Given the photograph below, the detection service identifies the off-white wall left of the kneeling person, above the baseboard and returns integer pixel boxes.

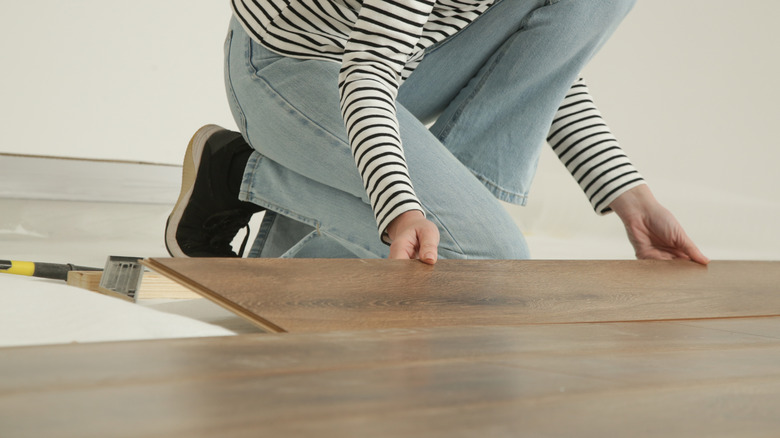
[0,0,233,163]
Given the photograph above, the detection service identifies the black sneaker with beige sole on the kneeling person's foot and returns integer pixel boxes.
[165,125,263,257]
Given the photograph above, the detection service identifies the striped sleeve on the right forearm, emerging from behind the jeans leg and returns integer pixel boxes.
[547,78,645,214]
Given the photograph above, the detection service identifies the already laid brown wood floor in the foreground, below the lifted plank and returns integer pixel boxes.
[0,317,780,438]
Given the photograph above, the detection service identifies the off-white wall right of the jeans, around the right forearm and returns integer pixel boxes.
[518,0,780,259]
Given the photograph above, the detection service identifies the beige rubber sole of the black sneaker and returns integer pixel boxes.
[165,125,225,257]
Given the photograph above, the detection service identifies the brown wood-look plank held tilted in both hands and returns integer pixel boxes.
[140,258,780,332]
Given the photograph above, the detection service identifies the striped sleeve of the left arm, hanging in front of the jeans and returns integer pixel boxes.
[339,0,435,243]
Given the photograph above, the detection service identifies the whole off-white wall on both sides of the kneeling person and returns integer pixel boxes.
[0,0,780,259]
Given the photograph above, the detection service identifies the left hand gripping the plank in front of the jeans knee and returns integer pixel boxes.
[387,210,439,265]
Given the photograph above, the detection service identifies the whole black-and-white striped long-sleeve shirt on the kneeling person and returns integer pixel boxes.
[231,0,641,240]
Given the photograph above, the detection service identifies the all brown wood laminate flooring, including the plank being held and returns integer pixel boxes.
[0,259,780,438]
